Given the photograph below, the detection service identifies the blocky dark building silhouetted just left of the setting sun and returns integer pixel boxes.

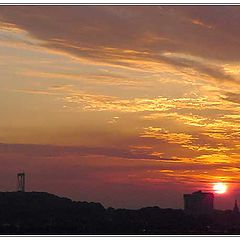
[183,191,214,215]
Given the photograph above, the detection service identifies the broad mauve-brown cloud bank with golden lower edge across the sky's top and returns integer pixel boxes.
[0,6,240,82]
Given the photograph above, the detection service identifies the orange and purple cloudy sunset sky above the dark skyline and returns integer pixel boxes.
[0,6,240,209]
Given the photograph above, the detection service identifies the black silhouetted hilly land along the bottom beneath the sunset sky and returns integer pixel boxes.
[0,192,240,235]
